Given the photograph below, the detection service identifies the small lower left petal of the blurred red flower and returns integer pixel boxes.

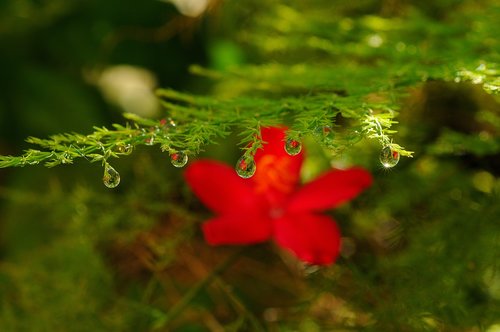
[202,213,272,245]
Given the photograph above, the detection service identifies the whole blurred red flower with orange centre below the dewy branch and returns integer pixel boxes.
[185,127,372,265]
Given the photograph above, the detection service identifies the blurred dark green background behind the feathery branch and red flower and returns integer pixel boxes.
[0,0,500,332]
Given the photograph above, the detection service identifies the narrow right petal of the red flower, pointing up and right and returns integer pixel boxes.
[288,167,372,212]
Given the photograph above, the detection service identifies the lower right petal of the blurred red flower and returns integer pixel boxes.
[274,213,340,265]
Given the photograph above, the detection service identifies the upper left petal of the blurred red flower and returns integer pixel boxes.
[184,160,263,214]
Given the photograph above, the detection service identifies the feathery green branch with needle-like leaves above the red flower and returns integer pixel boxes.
[0,3,500,171]
